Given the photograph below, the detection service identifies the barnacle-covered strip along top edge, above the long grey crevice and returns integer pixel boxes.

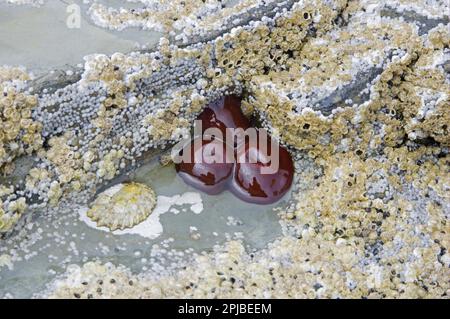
[88,0,292,43]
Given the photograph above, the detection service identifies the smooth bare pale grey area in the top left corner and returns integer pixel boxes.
[0,0,161,72]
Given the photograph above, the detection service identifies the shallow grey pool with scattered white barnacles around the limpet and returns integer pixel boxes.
[0,160,290,298]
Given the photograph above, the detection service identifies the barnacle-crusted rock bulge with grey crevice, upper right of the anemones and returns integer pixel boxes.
[249,18,450,157]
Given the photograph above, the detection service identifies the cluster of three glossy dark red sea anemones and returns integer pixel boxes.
[176,95,294,204]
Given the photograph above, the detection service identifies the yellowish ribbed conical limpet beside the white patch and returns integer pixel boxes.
[87,183,156,231]
